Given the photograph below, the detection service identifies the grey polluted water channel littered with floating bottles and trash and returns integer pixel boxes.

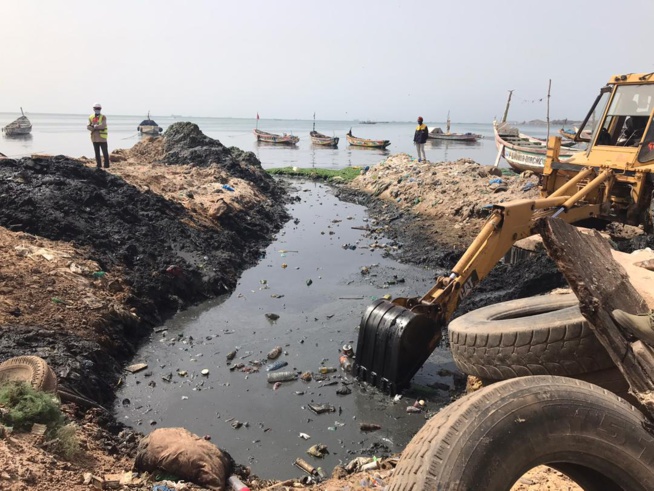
[115,181,455,479]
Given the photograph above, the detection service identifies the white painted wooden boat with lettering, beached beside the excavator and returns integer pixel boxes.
[493,121,581,173]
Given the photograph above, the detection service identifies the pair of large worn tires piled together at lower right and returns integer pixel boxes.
[390,295,654,491]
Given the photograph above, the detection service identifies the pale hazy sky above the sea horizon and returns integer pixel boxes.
[0,0,654,122]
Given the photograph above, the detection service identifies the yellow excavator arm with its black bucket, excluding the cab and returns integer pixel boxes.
[354,168,613,394]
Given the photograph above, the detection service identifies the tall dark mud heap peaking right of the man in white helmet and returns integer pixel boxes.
[163,122,279,194]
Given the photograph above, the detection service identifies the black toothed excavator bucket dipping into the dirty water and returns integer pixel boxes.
[354,300,442,395]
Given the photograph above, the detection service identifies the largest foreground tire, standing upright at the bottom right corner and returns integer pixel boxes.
[390,376,654,491]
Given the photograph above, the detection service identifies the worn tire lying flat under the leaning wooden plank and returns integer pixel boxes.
[448,294,615,380]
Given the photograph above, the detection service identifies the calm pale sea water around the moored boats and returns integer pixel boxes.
[0,113,558,169]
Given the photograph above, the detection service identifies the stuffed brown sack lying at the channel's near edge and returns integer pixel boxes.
[134,428,234,491]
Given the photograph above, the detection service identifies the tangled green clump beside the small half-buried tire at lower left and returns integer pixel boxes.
[0,382,65,431]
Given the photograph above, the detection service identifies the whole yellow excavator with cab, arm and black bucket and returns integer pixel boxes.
[354,73,654,394]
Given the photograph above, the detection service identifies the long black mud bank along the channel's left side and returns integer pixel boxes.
[0,154,288,403]
